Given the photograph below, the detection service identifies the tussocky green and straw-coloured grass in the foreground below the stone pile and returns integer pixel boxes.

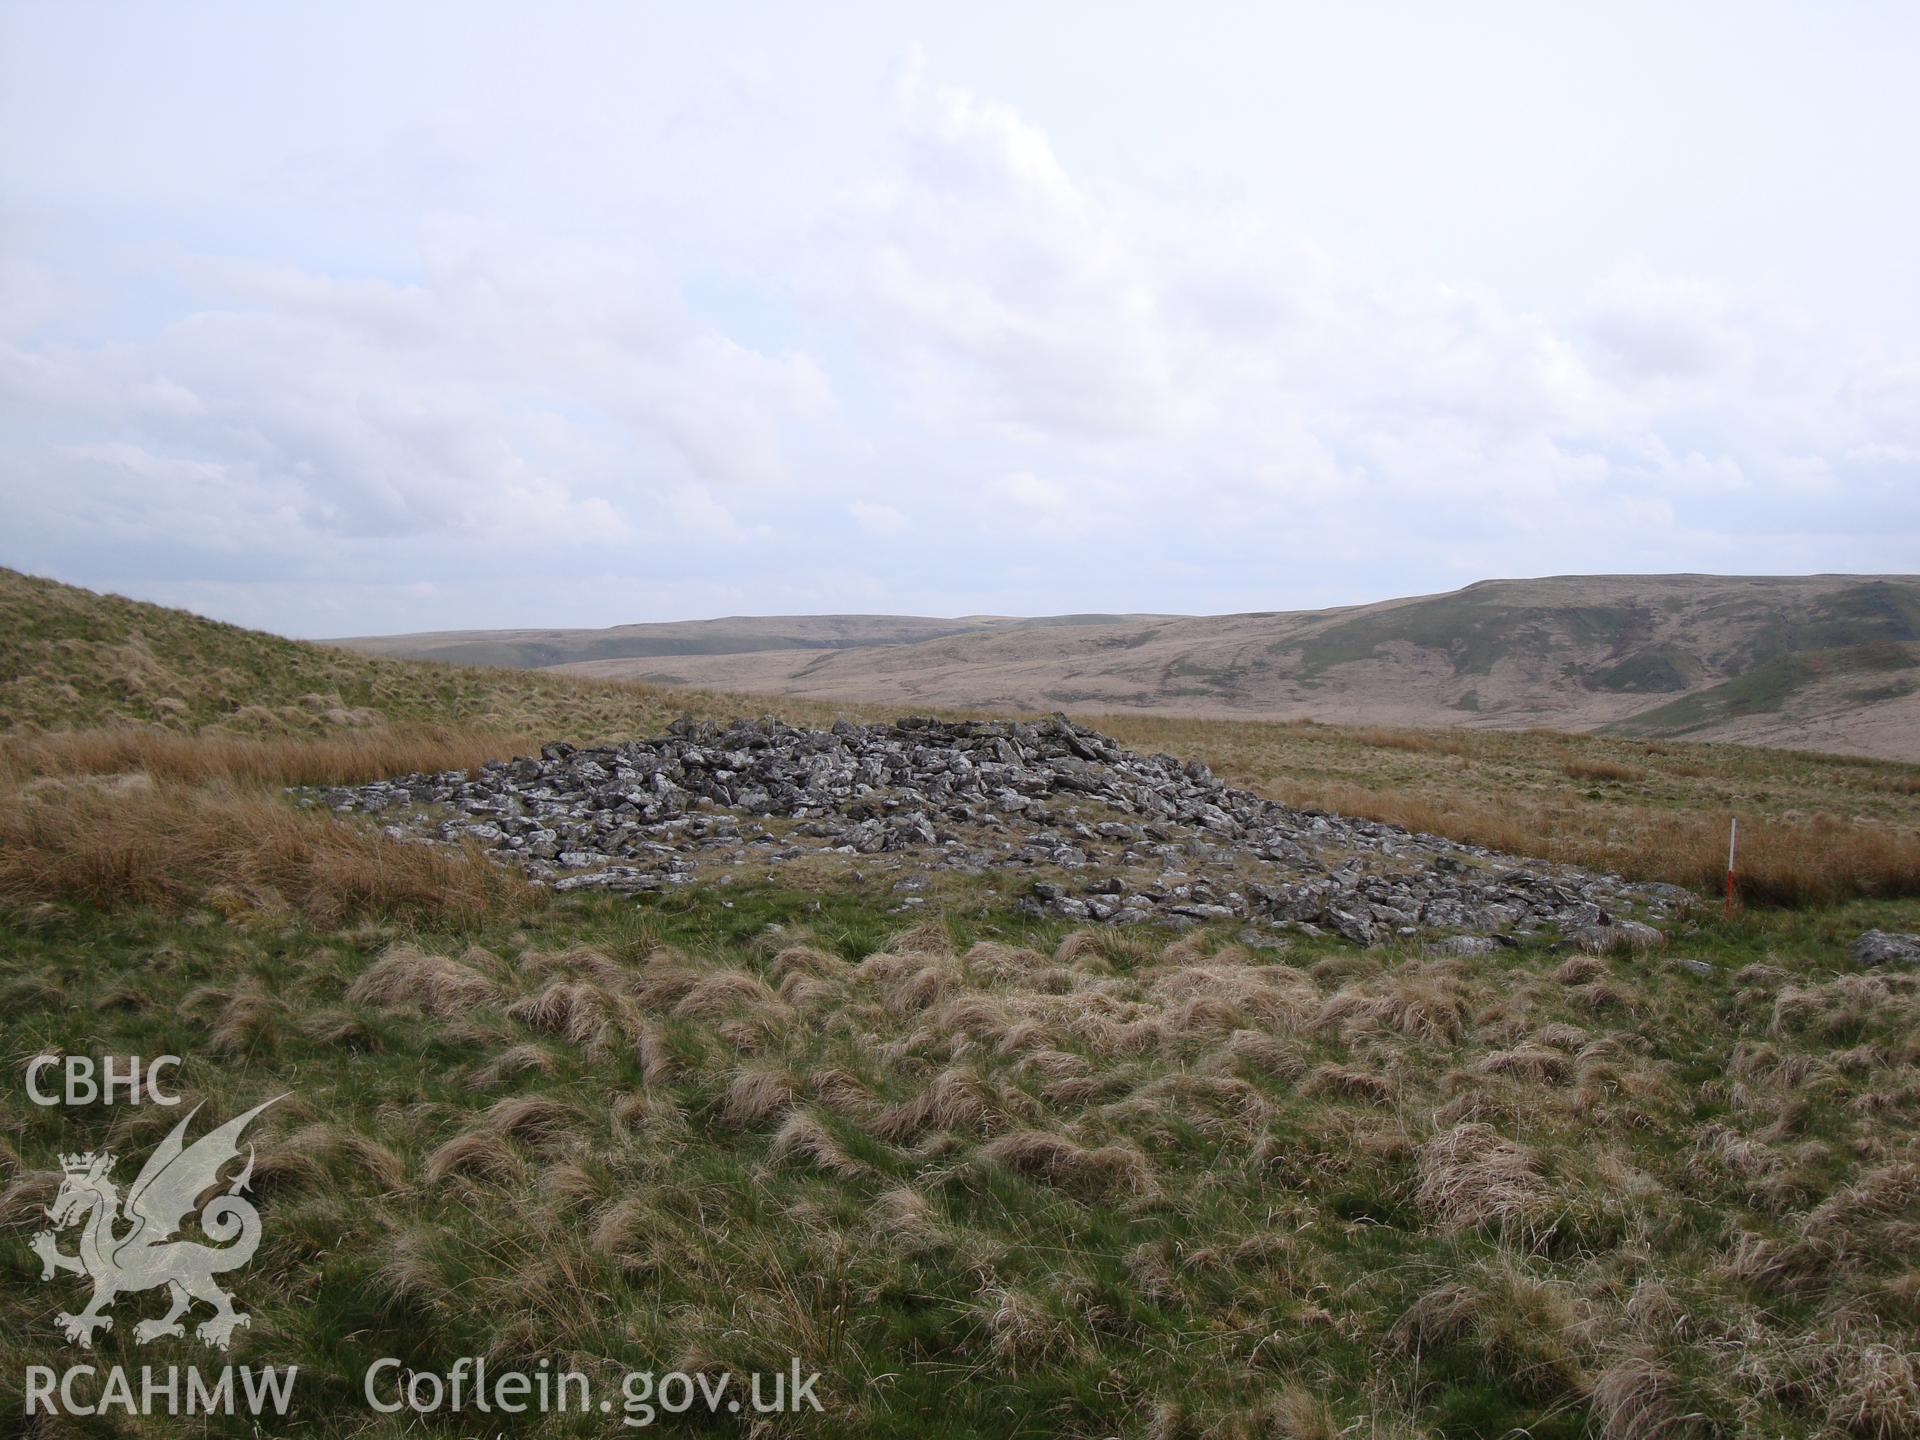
[0,889,1920,1440]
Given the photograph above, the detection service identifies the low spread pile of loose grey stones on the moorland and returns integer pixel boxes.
[307,716,1692,952]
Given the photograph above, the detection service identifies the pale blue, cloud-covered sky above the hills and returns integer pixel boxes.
[0,0,1920,636]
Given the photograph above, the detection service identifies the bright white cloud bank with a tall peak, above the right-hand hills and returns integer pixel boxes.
[841,57,1910,579]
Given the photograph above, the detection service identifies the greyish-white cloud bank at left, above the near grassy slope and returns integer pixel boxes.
[10,227,833,568]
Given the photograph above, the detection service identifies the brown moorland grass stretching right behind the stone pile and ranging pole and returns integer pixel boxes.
[1096,714,1920,904]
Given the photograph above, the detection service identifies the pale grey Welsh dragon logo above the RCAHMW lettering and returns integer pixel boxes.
[31,1094,286,1350]
